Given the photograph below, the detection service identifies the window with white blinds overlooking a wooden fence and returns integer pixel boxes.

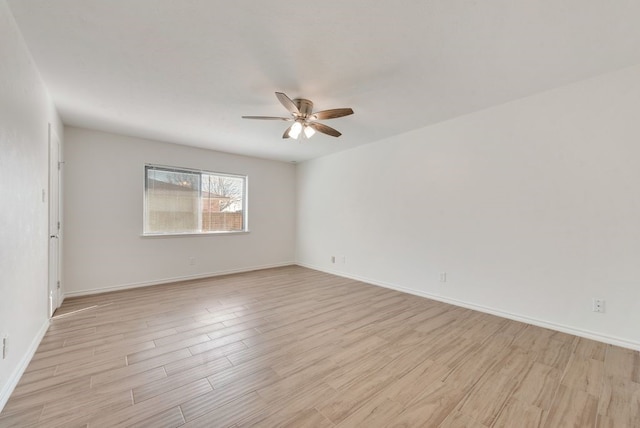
[143,165,247,235]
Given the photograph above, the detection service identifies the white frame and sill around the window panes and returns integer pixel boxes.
[140,163,250,238]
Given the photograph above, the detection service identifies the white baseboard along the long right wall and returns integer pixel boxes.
[297,263,640,351]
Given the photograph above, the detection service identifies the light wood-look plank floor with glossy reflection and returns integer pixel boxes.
[0,266,640,427]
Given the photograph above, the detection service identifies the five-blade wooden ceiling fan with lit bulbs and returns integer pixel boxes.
[242,92,353,139]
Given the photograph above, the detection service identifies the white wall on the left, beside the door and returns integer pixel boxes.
[0,1,63,409]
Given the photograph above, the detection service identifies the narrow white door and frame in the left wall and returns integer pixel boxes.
[47,123,62,318]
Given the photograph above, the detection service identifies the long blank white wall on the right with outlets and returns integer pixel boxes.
[297,66,640,349]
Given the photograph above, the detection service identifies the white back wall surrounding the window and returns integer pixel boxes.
[63,127,295,296]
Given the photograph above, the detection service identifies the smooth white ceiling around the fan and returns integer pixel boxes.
[8,0,640,161]
